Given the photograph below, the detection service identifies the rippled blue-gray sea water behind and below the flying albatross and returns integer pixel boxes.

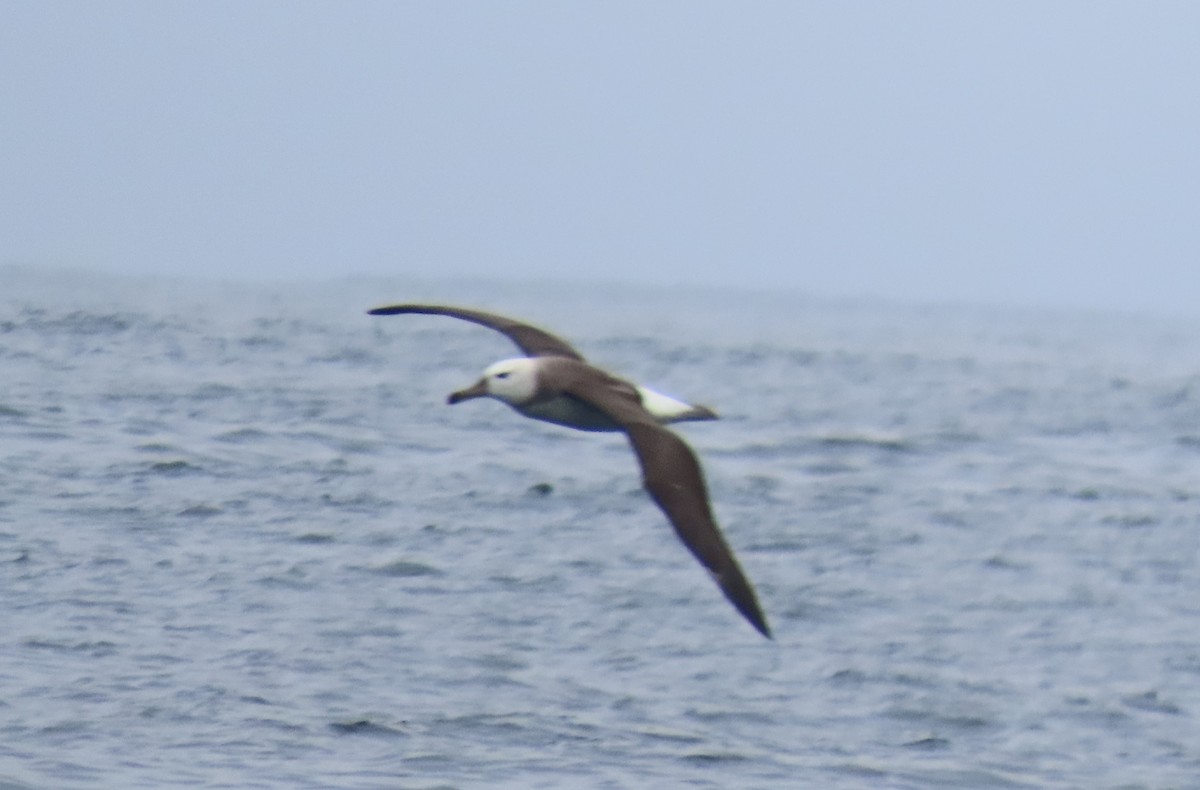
[0,269,1200,790]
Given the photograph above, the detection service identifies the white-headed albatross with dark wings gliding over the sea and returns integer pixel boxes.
[367,298,770,639]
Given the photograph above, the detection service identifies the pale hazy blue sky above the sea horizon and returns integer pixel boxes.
[0,0,1200,315]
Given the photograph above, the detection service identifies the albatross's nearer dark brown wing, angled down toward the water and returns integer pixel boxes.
[552,369,770,639]
